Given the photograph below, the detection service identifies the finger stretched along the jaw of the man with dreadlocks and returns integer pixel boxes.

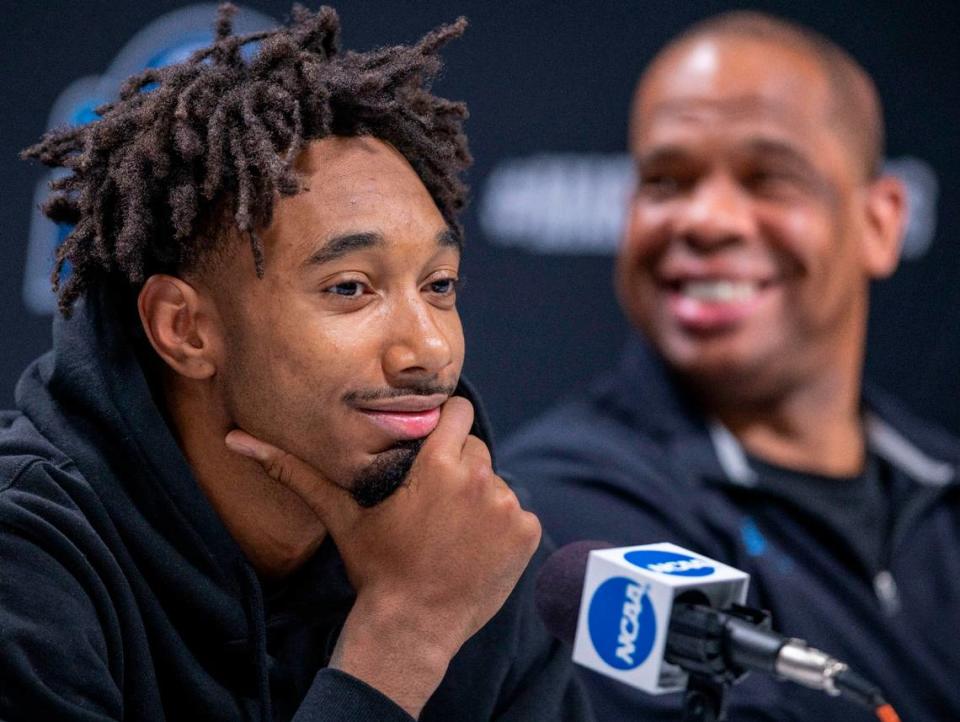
[224,429,355,536]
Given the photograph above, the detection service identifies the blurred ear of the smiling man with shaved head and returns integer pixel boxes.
[863,175,907,279]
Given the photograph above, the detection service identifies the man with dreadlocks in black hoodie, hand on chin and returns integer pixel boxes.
[0,6,586,722]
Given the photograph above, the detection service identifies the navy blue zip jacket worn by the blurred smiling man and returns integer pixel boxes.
[501,339,960,722]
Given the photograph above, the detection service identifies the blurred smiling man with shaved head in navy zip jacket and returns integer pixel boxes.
[505,13,960,722]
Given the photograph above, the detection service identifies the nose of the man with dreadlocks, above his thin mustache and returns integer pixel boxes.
[383,298,453,382]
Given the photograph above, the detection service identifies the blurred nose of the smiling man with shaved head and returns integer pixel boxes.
[674,173,756,251]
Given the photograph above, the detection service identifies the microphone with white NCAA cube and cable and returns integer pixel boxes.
[535,541,898,722]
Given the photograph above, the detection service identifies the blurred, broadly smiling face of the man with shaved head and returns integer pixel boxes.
[617,37,880,394]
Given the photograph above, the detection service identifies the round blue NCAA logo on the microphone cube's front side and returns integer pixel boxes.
[587,577,657,669]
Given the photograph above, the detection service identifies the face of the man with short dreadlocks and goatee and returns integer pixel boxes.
[205,138,464,504]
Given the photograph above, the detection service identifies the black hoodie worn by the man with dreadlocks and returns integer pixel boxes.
[0,294,587,722]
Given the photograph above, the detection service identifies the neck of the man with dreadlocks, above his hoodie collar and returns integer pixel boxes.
[164,379,326,578]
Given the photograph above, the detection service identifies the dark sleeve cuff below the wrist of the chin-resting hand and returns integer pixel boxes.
[291,669,413,722]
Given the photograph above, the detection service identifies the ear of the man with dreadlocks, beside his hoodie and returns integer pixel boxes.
[137,273,219,379]
